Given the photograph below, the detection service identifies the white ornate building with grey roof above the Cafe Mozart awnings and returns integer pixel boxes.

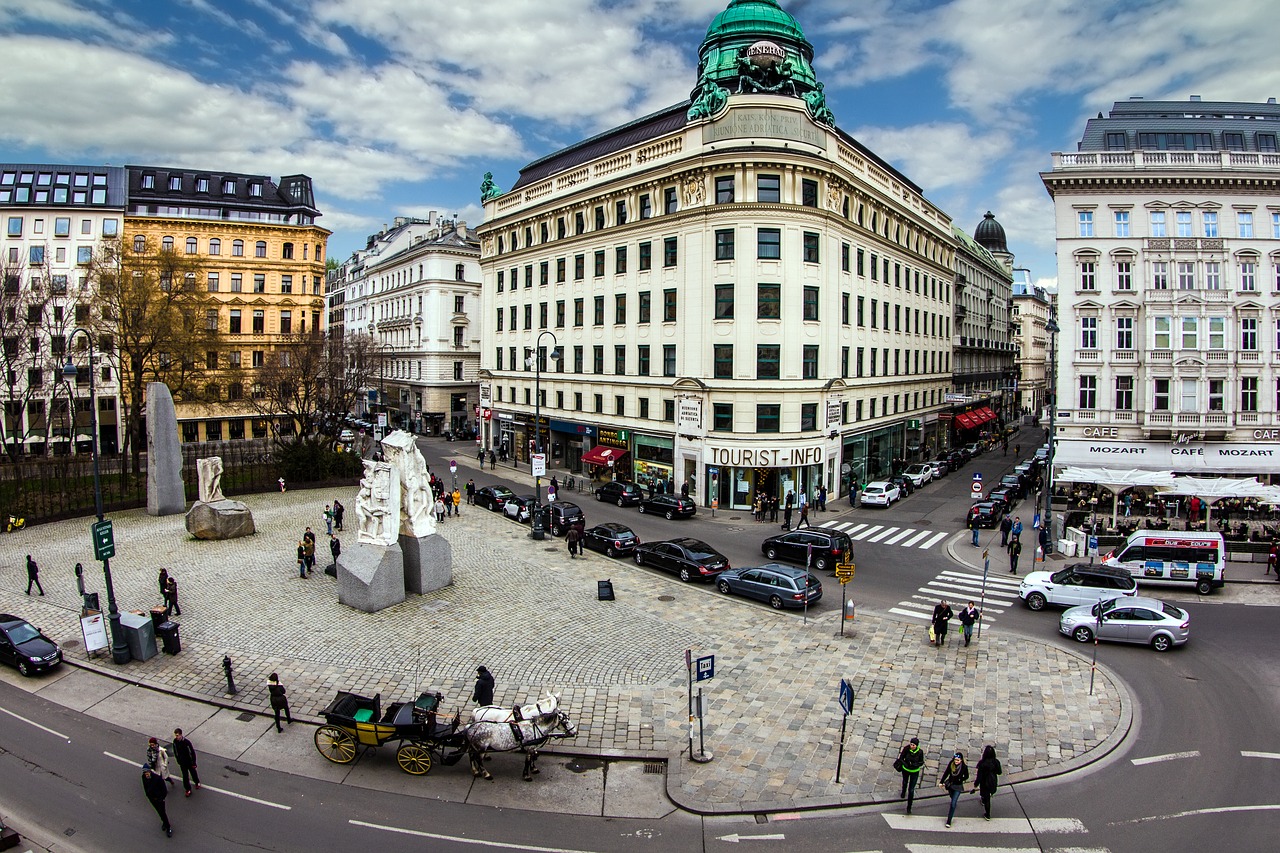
[1041,96,1280,475]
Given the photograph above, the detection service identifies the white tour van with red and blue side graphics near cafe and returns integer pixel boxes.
[1102,530,1226,596]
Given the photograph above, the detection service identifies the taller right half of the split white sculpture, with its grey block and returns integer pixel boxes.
[383,429,453,594]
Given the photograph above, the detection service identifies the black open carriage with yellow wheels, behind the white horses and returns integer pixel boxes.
[315,690,466,776]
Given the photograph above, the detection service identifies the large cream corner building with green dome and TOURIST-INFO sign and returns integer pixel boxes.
[479,0,962,510]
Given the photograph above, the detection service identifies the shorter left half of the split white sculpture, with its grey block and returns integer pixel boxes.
[337,460,404,613]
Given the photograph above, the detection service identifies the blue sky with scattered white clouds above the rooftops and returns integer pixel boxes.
[0,0,1280,283]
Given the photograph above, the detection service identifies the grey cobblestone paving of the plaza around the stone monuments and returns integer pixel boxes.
[0,479,1130,812]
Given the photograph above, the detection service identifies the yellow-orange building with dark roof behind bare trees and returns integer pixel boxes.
[123,165,329,442]
